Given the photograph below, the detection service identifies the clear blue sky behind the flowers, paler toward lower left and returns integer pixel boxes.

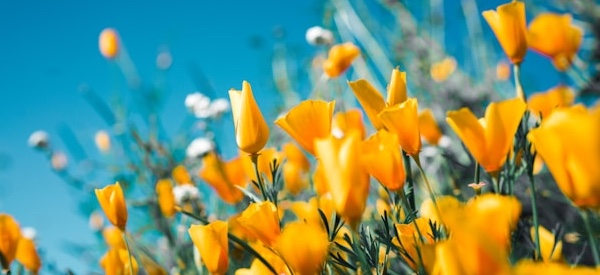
[0,0,572,273]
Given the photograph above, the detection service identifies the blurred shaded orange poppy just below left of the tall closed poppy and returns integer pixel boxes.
[199,152,247,204]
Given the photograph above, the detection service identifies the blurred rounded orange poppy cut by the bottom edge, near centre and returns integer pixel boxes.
[275,221,329,275]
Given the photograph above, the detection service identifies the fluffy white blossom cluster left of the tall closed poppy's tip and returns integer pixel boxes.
[185,92,230,118]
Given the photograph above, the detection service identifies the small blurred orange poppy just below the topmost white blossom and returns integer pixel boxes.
[323,42,360,77]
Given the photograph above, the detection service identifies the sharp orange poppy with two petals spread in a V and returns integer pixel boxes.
[348,69,407,130]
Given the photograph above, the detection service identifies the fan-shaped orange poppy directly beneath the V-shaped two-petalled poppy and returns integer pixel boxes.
[378,98,422,157]
